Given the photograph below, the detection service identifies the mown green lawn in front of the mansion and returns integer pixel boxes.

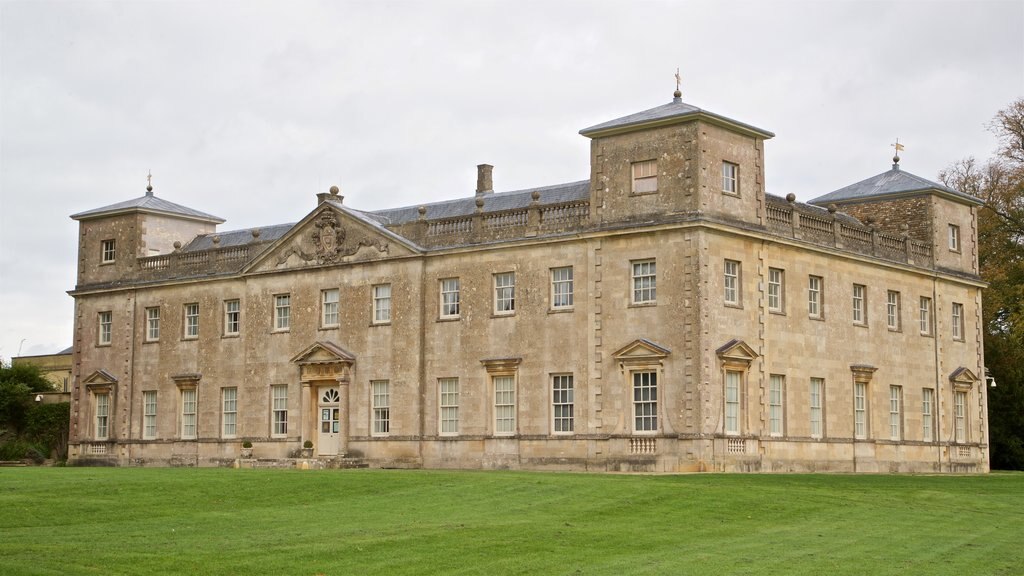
[0,468,1024,576]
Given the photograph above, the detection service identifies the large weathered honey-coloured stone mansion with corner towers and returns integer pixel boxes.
[70,91,989,472]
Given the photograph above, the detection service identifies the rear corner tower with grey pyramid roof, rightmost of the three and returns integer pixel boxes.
[810,156,983,275]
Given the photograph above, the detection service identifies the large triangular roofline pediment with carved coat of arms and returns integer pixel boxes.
[247,202,419,272]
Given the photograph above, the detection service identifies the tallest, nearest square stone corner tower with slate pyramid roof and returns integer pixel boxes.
[580,90,774,224]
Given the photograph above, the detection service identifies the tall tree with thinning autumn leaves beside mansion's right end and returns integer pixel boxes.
[939,98,1024,469]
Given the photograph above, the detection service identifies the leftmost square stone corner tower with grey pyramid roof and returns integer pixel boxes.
[71,186,224,286]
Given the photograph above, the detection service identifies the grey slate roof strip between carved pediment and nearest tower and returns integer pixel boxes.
[364,180,590,224]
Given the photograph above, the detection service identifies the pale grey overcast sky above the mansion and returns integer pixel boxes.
[0,0,1024,360]
